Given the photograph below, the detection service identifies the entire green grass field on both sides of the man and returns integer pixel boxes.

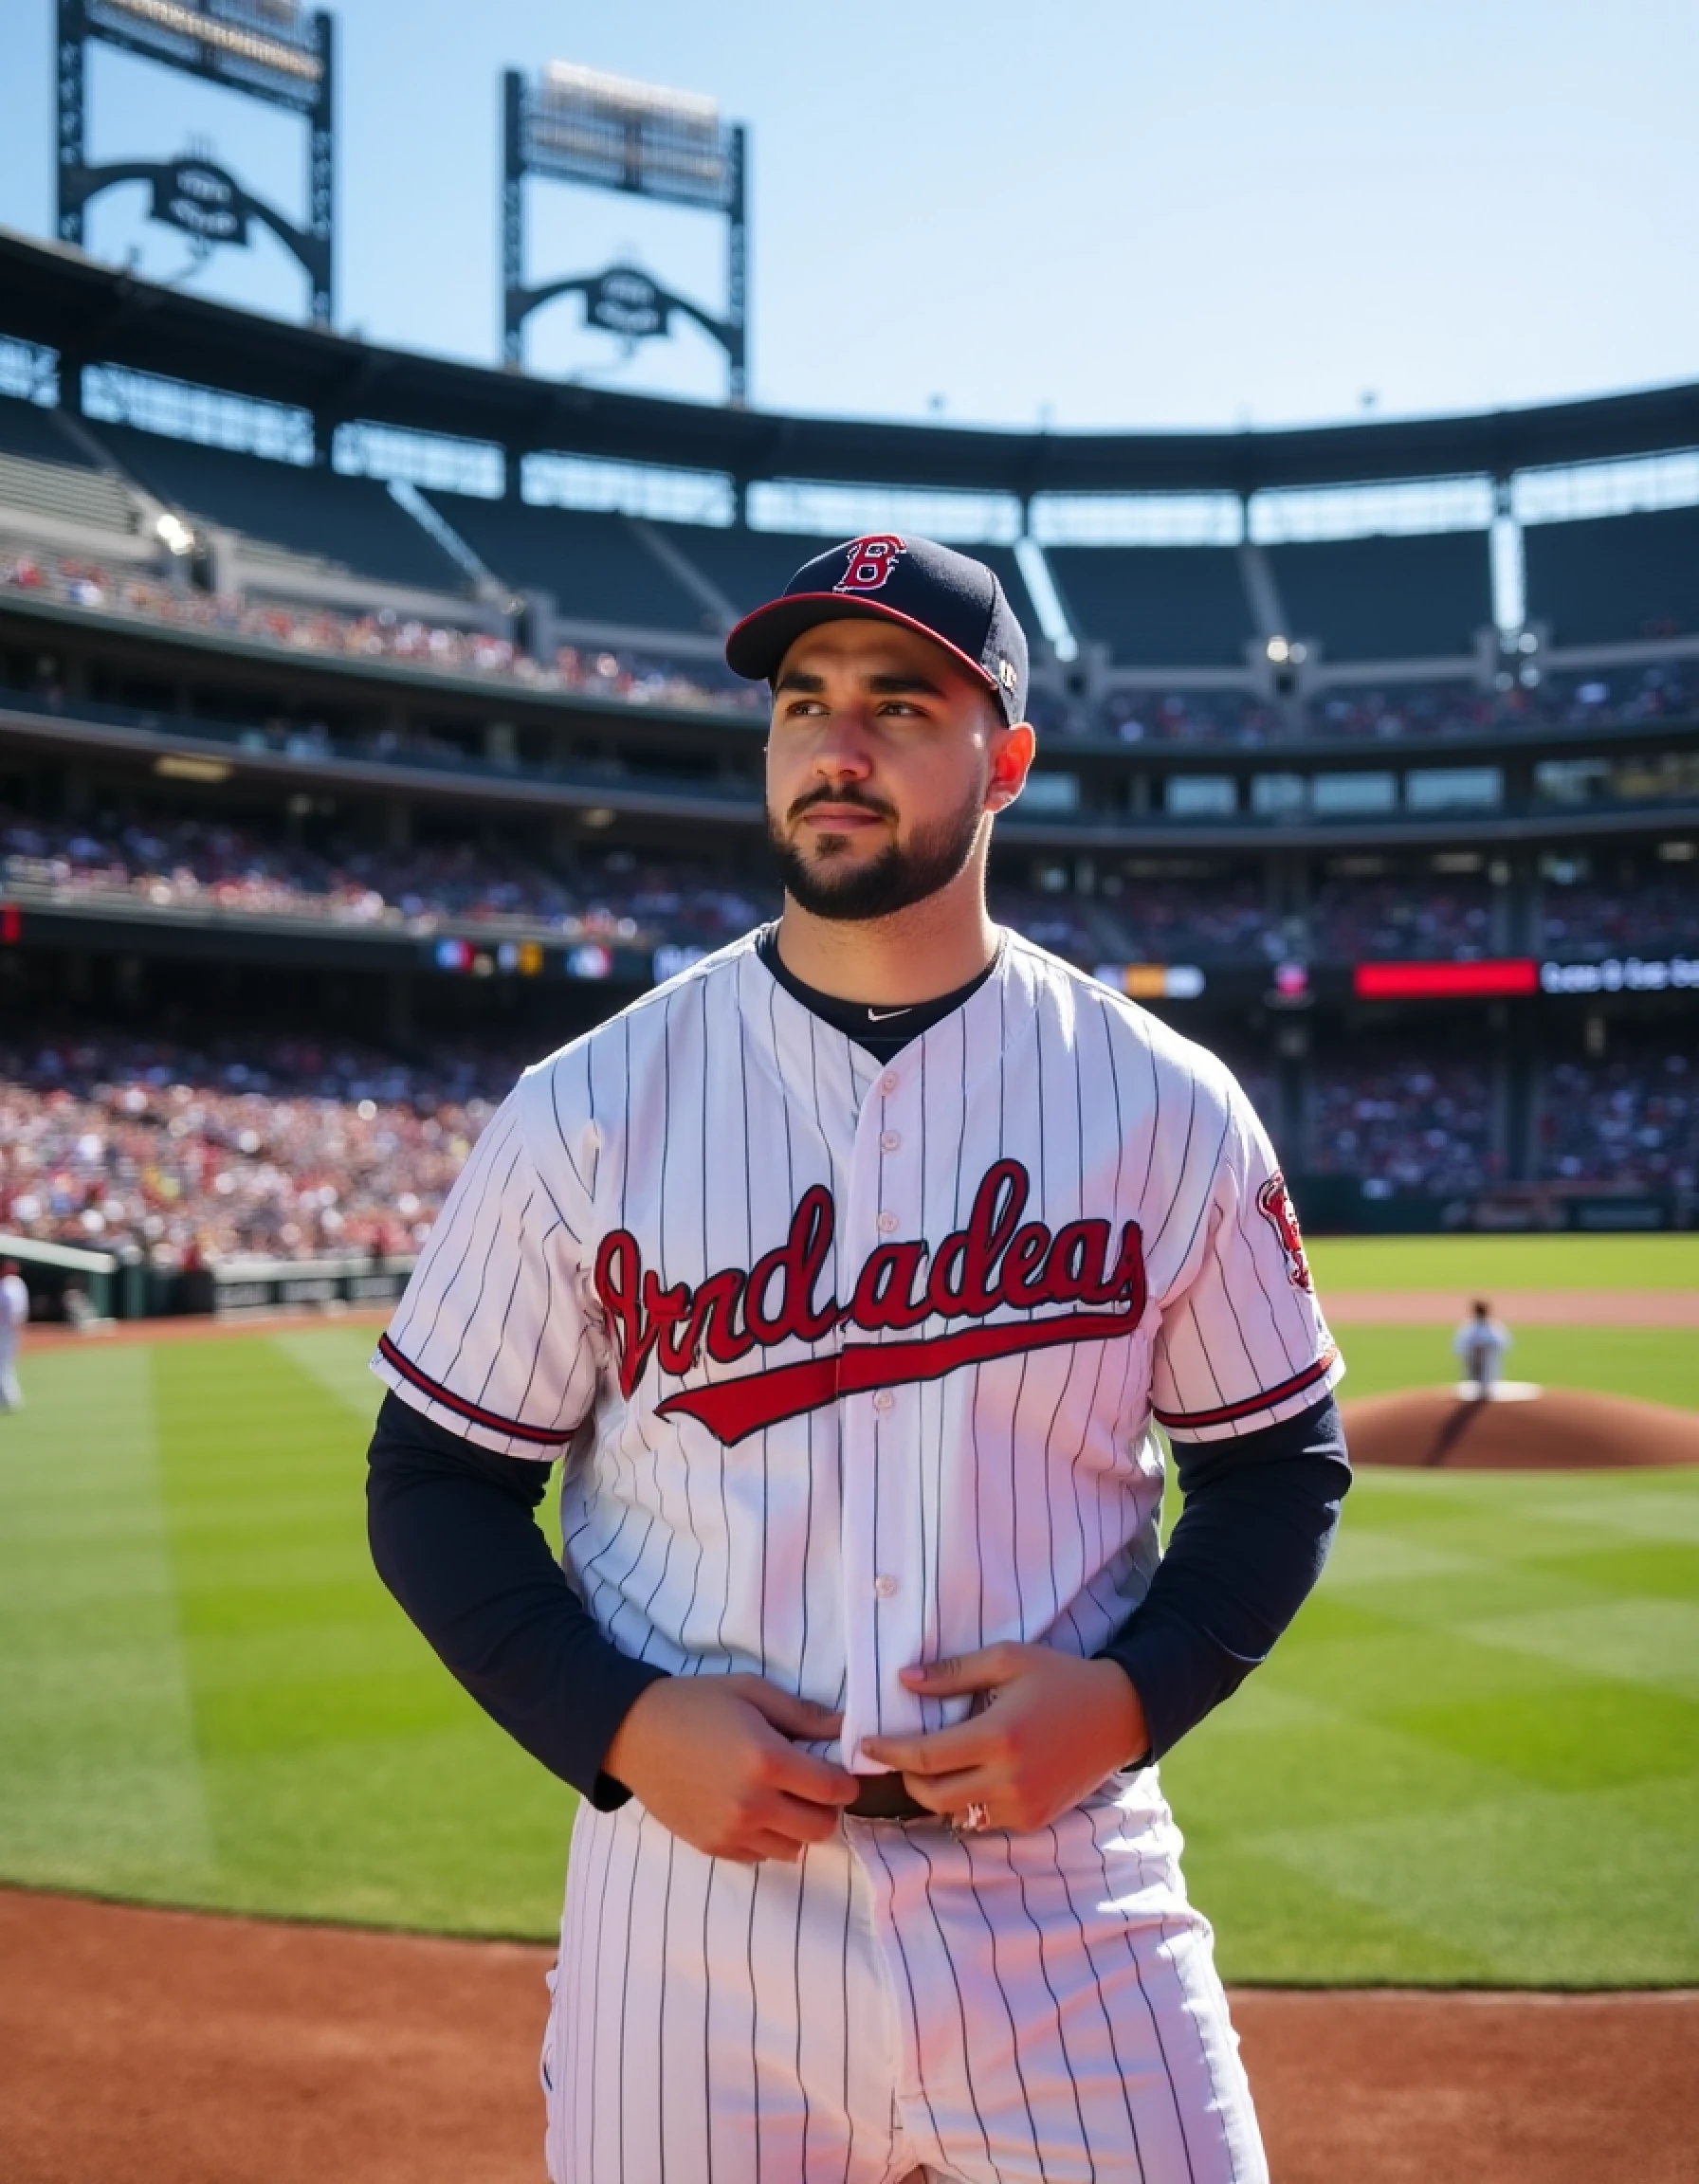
[0,1238,1699,1988]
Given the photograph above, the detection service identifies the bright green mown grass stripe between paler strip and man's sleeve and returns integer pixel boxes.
[153,1328,570,1935]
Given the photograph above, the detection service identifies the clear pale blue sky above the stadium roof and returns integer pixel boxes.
[0,0,1699,426]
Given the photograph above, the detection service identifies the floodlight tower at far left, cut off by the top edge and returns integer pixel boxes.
[57,0,334,325]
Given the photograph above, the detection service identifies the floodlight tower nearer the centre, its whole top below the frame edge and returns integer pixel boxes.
[502,62,749,402]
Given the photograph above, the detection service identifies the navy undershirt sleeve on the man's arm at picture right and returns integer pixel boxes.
[1099,1395,1352,1760]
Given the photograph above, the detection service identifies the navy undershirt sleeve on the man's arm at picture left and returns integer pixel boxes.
[367,1395,667,1812]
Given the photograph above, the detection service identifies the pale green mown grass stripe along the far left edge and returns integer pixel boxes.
[0,1348,210,1894]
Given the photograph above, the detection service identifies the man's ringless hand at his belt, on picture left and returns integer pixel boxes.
[603,1675,858,1866]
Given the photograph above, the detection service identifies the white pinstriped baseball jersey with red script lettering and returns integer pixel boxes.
[374,935,1341,1767]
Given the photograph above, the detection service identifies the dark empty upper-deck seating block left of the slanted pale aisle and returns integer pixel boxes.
[99,424,466,594]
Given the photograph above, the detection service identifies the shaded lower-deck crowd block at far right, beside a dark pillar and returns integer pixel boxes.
[1538,1050,1699,1191]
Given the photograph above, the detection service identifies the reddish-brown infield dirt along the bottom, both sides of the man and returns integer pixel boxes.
[0,1891,1699,2184]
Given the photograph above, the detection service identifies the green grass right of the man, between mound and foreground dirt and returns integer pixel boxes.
[1161,1472,1699,1988]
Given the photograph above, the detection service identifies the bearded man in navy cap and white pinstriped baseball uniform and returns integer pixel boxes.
[372,537,1347,2184]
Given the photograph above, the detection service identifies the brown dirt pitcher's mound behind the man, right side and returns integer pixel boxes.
[1341,1387,1699,1472]
